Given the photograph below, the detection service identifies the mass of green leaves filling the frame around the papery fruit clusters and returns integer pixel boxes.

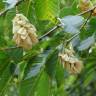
[0,0,96,96]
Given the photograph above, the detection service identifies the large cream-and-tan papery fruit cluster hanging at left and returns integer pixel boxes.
[13,14,38,49]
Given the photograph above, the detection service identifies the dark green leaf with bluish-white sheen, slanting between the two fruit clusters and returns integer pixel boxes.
[25,52,48,80]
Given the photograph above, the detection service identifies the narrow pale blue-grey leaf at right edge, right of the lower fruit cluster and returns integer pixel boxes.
[78,36,95,51]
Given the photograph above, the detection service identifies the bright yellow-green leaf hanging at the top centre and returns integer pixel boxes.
[35,0,59,20]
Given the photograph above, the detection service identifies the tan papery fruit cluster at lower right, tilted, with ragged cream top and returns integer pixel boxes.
[59,49,83,74]
